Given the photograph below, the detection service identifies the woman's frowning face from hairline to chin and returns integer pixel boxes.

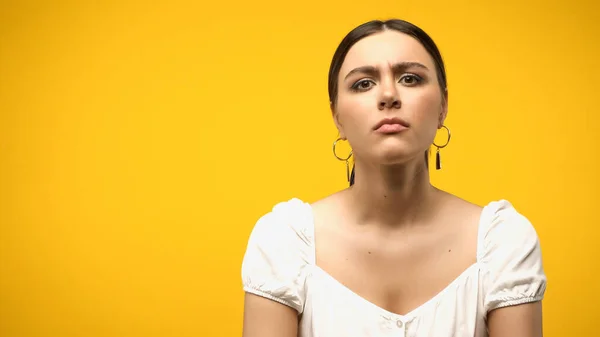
[333,30,447,165]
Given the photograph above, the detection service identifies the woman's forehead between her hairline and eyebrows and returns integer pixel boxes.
[340,30,435,75]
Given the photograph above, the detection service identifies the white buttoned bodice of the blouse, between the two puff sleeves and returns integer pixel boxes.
[299,265,487,337]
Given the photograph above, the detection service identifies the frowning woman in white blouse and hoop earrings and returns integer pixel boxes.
[242,20,546,337]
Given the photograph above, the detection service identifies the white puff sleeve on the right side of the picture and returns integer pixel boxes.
[481,200,547,312]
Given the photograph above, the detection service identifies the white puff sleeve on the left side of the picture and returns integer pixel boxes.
[242,199,313,314]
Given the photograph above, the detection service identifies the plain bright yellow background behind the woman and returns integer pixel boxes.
[0,0,600,337]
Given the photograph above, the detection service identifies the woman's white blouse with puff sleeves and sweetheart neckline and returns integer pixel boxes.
[242,198,546,337]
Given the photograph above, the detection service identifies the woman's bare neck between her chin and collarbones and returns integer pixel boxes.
[348,161,439,227]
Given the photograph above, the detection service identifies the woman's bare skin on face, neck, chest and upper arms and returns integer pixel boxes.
[243,31,542,337]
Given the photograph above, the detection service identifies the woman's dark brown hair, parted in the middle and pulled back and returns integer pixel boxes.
[329,19,447,186]
